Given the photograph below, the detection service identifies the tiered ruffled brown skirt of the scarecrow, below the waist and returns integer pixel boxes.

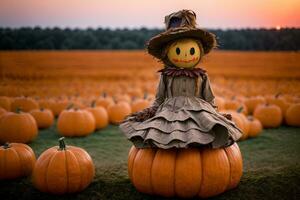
[120,96,242,149]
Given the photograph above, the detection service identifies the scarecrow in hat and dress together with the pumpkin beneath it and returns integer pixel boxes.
[120,10,242,197]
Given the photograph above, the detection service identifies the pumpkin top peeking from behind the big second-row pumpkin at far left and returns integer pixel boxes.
[11,97,39,112]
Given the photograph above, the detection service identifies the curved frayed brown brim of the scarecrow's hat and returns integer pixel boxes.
[147,27,217,59]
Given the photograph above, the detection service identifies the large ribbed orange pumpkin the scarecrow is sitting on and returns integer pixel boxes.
[128,143,243,198]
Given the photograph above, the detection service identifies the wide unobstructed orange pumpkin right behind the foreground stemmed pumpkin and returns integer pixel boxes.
[57,108,96,137]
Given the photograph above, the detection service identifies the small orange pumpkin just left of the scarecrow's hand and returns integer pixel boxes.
[107,101,131,124]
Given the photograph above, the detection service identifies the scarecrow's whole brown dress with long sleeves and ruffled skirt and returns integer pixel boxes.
[120,68,242,149]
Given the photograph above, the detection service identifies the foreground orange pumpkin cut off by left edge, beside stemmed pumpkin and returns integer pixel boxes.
[0,143,35,180]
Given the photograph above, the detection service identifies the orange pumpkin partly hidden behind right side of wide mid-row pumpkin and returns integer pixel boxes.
[86,102,109,129]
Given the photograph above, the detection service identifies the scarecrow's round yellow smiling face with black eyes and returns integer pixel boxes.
[167,39,201,68]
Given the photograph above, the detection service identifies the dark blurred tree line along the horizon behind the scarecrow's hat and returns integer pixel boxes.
[0,27,300,51]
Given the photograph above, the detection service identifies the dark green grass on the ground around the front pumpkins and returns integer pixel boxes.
[0,123,300,200]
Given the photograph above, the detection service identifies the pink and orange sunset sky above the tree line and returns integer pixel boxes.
[0,0,300,29]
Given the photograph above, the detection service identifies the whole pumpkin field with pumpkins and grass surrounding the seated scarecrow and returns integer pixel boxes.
[0,51,300,199]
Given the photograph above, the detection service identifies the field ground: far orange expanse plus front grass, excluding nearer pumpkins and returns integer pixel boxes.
[0,51,300,199]
